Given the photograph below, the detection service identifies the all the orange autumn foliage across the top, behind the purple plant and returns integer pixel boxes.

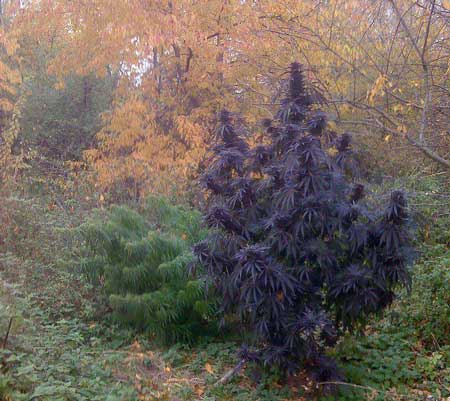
[4,0,449,196]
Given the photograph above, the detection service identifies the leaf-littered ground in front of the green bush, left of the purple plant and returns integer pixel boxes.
[0,254,298,401]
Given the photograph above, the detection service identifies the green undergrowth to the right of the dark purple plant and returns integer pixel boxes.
[326,176,450,401]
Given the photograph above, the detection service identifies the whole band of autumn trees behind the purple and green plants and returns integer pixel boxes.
[0,0,450,202]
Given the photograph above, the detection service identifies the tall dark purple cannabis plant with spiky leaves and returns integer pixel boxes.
[194,63,409,381]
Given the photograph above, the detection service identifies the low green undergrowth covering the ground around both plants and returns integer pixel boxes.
[0,179,450,401]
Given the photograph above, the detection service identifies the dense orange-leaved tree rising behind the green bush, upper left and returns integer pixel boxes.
[13,0,284,196]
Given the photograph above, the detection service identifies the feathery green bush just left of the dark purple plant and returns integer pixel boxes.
[80,198,214,342]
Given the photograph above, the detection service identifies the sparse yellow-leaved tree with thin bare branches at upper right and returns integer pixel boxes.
[253,0,450,168]
